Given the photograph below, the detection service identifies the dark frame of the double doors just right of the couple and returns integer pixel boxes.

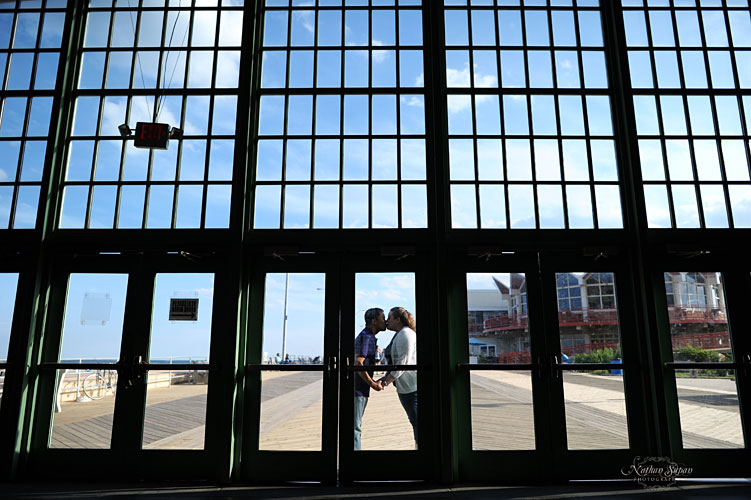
[450,250,651,480]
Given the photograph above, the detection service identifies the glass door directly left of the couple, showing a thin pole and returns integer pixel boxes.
[243,257,340,482]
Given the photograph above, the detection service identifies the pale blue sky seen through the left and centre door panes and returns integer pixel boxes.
[22,273,419,361]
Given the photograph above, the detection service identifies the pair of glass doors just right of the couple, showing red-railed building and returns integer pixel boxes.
[454,255,644,479]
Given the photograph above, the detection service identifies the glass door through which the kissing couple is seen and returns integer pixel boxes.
[339,255,440,481]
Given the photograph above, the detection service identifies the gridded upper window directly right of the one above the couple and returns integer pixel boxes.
[444,0,623,229]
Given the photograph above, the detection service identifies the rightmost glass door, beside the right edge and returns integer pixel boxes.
[655,257,751,477]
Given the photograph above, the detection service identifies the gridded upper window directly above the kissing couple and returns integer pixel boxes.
[253,0,428,229]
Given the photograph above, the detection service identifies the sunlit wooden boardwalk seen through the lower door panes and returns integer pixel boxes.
[50,371,743,451]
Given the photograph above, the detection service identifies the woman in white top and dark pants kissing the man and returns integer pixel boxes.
[380,307,417,449]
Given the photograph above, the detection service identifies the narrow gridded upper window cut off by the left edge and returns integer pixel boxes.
[0,0,66,229]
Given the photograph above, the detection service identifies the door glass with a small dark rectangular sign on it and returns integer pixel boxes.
[142,273,214,449]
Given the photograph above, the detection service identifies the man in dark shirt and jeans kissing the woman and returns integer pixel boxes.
[355,307,386,450]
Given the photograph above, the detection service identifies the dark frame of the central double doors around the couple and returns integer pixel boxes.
[242,248,440,483]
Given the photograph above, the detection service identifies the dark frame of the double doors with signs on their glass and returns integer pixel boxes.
[27,252,239,480]
